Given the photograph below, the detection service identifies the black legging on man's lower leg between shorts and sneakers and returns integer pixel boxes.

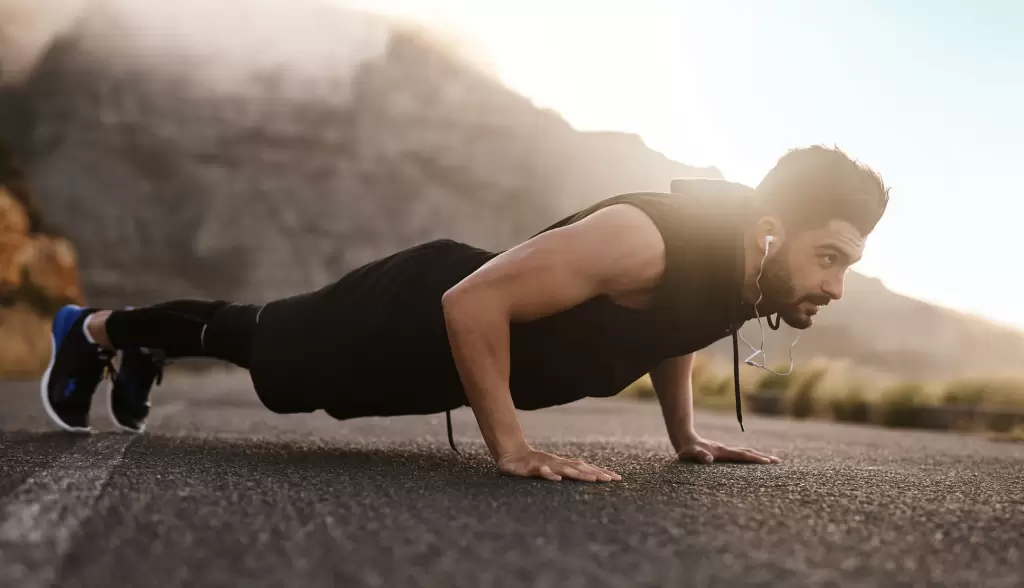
[106,299,260,370]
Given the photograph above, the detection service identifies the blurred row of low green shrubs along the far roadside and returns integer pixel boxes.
[624,354,1024,440]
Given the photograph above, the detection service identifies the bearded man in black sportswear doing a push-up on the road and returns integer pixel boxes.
[41,146,889,481]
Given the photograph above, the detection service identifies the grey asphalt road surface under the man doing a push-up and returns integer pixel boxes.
[0,373,1024,588]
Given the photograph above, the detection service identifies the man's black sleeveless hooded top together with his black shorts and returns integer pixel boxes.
[251,180,753,428]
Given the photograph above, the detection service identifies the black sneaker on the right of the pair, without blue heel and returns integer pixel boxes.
[108,348,165,433]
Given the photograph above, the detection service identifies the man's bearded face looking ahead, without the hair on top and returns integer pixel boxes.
[758,220,864,329]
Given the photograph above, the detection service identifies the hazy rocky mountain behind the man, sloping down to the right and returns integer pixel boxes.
[0,0,1024,385]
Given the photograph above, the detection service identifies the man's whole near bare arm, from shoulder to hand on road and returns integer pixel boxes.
[442,205,665,479]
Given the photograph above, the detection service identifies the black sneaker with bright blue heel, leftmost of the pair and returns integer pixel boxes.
[39,304,114,432]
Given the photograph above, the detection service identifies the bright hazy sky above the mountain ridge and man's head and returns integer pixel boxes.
[349,0,1024,328]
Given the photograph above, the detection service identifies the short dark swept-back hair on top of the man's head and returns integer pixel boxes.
[757,145,889,236]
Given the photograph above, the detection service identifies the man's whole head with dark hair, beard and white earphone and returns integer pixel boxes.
[746,145,889,329]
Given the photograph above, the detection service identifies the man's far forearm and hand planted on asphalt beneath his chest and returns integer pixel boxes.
[650,353,779,463]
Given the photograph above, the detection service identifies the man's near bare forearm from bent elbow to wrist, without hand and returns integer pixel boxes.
[444,296,526,461]
